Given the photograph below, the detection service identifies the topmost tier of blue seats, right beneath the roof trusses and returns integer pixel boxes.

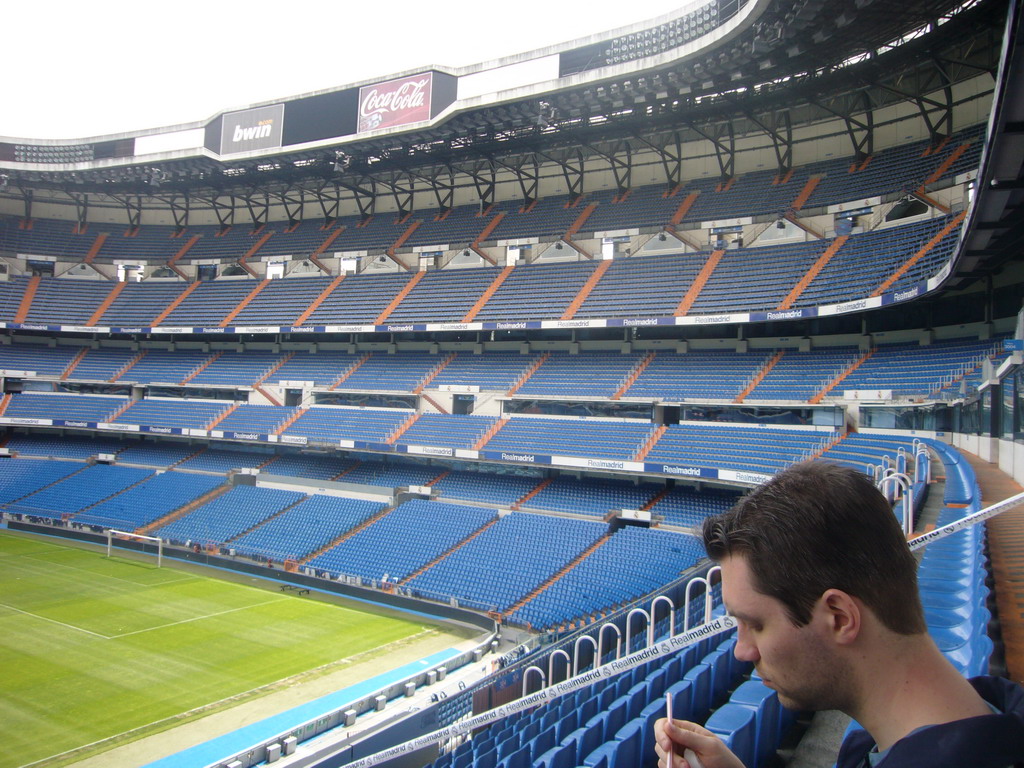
[0,124,985,280]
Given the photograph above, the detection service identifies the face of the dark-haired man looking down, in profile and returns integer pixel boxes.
[721,555,852,711]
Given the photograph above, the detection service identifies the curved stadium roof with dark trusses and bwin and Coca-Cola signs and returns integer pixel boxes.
[0,0,1007,208]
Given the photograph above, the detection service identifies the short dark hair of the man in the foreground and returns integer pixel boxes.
[703,462,926,635]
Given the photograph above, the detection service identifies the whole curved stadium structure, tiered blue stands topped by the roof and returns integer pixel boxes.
[0,0,1024,765]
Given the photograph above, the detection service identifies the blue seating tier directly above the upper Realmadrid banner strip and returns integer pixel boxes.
[0,216,959,328]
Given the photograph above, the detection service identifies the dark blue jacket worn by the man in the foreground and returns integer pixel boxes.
[836,677,1024,768]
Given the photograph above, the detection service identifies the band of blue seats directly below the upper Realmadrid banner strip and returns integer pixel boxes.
[0,336,1008,399]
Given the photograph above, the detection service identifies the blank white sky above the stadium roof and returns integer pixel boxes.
[0,0,686,139]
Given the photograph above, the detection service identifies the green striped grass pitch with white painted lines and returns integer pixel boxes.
[0,530,436,768]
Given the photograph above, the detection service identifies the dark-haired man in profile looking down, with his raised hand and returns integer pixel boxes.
[654,462,1024,768]
